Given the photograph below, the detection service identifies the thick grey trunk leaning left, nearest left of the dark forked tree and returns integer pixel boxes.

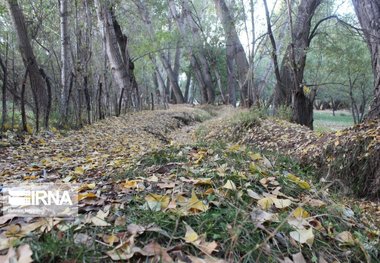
[214,0,252,107]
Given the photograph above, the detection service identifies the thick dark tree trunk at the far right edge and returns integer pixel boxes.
[352,0,380,119]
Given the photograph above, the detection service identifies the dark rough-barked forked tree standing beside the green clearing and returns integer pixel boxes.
[274,0,322,129]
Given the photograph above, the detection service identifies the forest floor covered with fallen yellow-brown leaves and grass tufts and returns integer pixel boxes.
[0,106,380,263]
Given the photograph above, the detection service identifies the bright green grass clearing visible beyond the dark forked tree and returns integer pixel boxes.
[314,110,354,132]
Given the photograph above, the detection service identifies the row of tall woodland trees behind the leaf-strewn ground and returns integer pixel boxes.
[0,0,380,130]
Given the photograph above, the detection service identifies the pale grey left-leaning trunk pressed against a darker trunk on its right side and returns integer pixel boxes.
[95,0,132,113]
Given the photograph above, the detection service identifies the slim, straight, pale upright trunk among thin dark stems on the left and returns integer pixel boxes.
[59,0,70,124]
